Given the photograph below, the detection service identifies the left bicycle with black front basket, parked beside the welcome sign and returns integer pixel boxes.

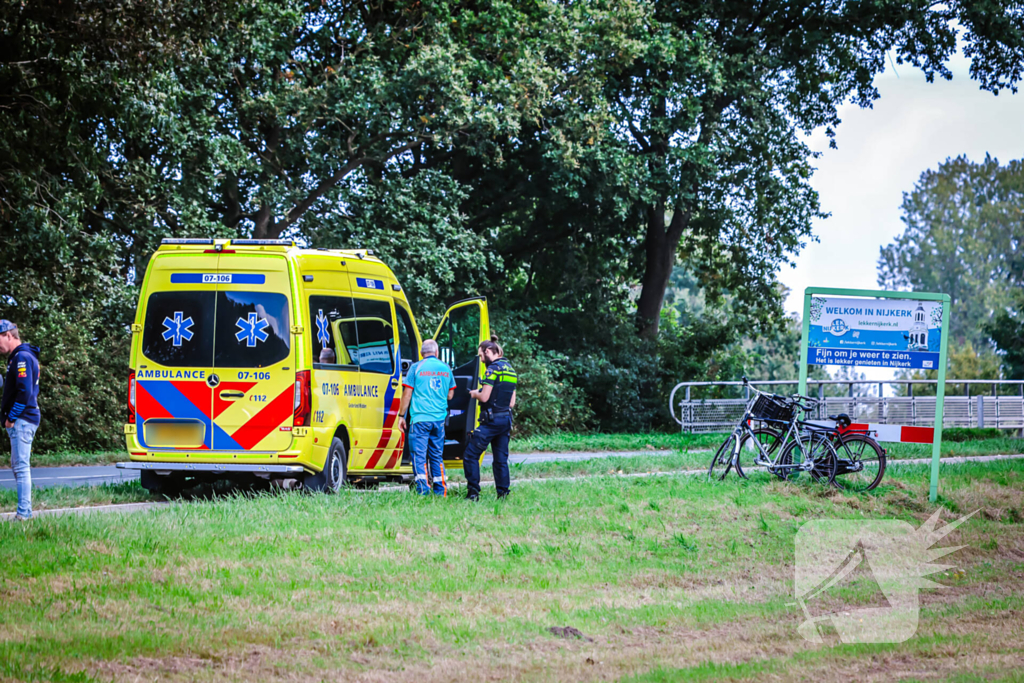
[708,377,839,485]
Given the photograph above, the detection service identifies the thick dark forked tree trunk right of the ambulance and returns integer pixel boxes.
[637,200,689,339]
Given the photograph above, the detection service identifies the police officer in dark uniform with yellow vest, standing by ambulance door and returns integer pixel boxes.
[462,338,517,501]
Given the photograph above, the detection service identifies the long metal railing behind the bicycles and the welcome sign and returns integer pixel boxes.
[669,380,1024,435]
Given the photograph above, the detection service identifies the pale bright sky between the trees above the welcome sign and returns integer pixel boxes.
[779,56,1024,394]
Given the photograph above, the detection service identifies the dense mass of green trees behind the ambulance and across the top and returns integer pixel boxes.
[0,0,1024,442]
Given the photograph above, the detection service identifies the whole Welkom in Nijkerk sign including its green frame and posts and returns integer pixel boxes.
[800,287,950,502]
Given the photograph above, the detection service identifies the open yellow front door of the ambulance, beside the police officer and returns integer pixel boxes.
[434,297,490,467]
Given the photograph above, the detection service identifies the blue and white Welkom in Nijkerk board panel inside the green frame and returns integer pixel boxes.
[807,297,942,370]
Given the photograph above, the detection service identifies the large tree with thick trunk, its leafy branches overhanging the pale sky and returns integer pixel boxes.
[607,0,1024,336]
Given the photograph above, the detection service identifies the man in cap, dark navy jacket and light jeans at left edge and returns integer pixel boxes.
[0,319,39,520]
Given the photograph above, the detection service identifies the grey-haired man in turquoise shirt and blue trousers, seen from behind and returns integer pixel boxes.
[398,339,455,496]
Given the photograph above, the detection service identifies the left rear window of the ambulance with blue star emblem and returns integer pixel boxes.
[142,292,214,368]
